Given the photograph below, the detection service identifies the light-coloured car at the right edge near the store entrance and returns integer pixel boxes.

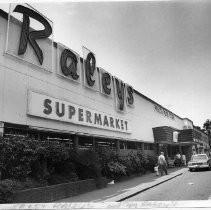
[188,154,211,171]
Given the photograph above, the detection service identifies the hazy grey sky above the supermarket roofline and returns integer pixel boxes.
[0,0,211,127]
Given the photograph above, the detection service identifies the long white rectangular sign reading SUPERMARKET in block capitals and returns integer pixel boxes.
[28,91,131,133]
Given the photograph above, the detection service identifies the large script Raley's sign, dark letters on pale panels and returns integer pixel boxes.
[6,4,134,112]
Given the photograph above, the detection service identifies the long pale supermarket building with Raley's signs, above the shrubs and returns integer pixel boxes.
[0,4,209,162]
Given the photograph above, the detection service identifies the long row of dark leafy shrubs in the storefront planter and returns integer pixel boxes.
[0,136,157,203]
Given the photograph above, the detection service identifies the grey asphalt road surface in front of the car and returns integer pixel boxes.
[125,170,211,201]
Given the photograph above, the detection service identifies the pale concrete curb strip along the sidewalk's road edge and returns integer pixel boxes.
[102,168,188,202]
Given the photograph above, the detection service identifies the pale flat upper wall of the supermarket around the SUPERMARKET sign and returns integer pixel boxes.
[0,10,188,142]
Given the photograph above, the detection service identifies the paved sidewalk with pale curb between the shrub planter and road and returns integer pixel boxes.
[56,168,188,203]
